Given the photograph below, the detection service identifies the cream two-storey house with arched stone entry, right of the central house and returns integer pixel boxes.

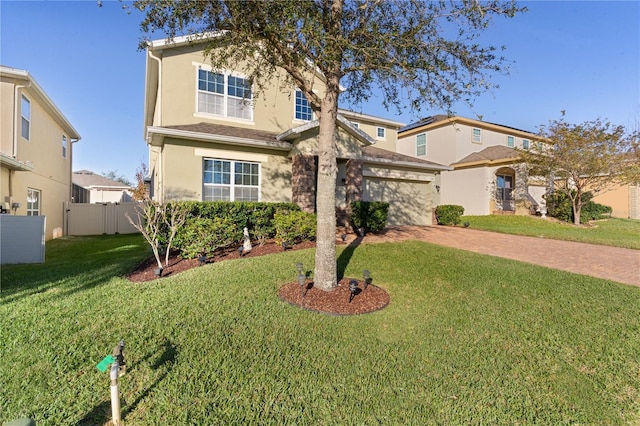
[397,115,546,215]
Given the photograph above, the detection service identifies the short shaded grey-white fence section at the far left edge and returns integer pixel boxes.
[0,214,46,264]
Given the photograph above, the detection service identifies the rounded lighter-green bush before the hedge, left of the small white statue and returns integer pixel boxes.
[174,217,242,259]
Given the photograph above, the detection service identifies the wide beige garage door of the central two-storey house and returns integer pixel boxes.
[363,177,432,226]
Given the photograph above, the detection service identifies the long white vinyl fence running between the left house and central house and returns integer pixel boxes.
[64,202,138,235]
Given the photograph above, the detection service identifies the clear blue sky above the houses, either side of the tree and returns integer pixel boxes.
[0,0,640,181]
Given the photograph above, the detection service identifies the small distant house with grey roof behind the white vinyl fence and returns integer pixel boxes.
[72,170,133,203]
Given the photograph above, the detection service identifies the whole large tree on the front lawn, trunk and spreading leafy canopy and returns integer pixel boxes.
[133,0,523,290]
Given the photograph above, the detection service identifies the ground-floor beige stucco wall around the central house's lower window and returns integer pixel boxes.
[154,138,291,202]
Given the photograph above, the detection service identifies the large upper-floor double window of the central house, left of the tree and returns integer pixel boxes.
[198,69,253,120]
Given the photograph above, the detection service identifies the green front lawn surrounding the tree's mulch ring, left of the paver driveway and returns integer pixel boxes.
[0,235,640,426]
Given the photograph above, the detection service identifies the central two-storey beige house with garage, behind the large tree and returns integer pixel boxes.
[145,37,450,225]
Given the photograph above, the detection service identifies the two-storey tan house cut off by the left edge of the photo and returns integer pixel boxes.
[0,66,80,240]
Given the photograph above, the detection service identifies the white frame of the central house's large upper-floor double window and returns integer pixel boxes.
[195,66,254,122]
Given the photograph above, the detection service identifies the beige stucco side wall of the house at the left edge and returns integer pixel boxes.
[0,81,72,240]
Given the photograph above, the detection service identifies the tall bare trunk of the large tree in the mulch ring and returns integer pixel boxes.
[313,82,339,291]
